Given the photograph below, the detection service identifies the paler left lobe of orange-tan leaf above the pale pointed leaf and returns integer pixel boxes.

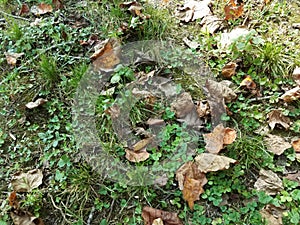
[203,124,224,154]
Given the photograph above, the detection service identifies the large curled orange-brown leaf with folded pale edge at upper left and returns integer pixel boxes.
[90,38,120,71]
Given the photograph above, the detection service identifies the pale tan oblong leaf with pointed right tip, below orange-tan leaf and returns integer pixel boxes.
[195,153,236,173]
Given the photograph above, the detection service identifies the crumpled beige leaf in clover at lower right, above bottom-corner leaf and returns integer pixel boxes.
[254,169,283,195]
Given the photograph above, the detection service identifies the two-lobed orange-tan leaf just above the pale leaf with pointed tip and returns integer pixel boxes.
[203,124,236,154]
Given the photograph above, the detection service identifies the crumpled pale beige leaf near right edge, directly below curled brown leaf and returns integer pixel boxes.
[264,134,292,155]
